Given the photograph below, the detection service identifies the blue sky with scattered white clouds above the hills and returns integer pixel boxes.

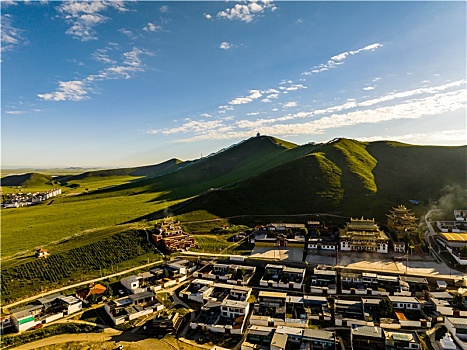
[1,1,467,167]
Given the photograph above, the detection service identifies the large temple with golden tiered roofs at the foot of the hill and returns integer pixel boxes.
[339,217,389,253]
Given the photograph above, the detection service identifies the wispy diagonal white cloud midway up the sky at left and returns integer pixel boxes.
[37,47,151,101]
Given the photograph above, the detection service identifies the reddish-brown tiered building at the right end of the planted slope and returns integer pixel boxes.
[152,218,196,253]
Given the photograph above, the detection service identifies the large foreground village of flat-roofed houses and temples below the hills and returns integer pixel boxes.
[2,205,467,350]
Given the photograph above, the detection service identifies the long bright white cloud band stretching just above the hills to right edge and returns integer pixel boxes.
[152,84,467,142]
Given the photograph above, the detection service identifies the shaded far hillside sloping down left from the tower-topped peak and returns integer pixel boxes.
[92,136,317,200]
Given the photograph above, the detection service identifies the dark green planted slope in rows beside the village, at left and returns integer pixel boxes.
[1,230,160,303]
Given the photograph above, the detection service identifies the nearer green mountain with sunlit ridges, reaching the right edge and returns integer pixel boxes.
[153,139,467,218]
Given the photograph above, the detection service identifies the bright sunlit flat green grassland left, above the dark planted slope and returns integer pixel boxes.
[1,193,186,258]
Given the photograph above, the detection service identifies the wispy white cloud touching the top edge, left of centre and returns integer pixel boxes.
[56,0,128,41]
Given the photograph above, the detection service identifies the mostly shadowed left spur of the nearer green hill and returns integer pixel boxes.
[170,153,343,217]
